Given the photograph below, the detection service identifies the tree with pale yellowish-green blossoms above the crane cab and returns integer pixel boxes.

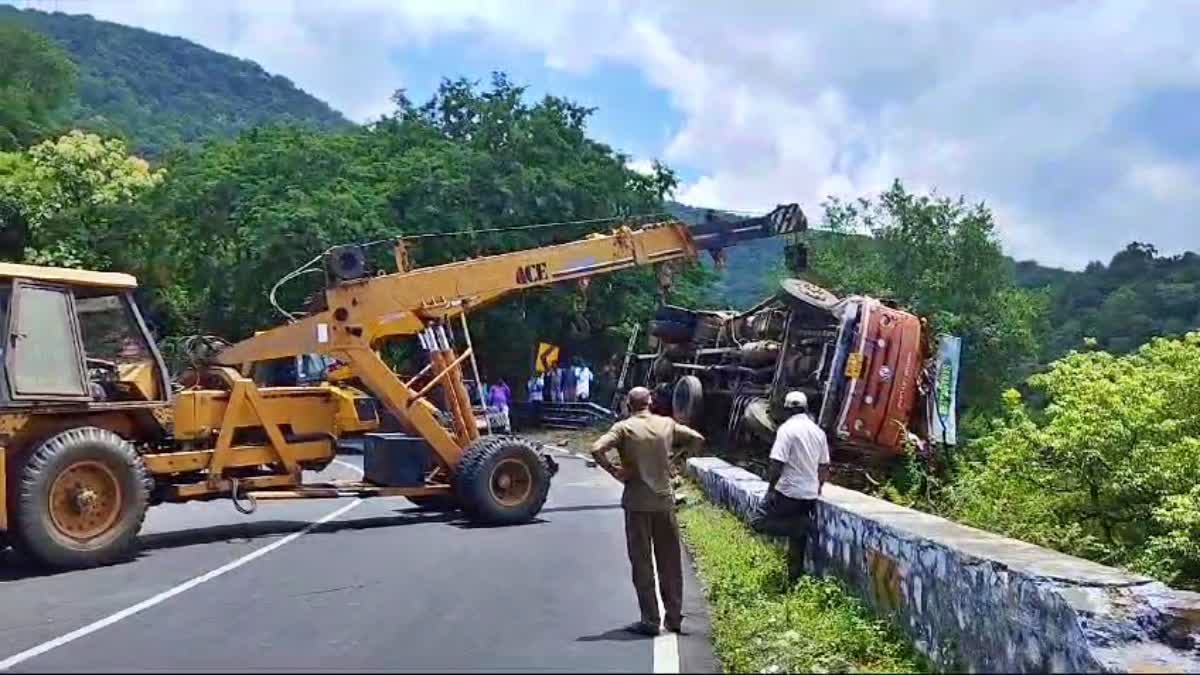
[0,131,162,269]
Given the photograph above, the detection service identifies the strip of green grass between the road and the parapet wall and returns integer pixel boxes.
[679,486,929,673]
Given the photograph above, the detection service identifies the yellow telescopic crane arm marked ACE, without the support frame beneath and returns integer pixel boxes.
[217,204,808,365]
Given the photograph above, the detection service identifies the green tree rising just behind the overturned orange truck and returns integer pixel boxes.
[809,181,1046,406]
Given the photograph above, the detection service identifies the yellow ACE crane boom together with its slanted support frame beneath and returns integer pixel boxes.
[216,204,808,474]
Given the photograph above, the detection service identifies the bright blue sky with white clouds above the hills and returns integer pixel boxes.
[10,0,1200,269]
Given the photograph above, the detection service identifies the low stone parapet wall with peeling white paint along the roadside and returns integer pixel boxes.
[688,458,1200,673]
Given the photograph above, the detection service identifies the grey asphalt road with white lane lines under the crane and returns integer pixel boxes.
[0,444,713,673]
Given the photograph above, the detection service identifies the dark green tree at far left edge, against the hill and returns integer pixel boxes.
[0,22,77,150]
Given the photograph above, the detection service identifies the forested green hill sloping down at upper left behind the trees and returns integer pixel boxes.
[0,5,350,156]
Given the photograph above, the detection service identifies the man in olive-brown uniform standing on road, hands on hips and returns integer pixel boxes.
[592,387,704,635]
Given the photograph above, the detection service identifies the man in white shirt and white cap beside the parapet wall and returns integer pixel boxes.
[750,392,829,581]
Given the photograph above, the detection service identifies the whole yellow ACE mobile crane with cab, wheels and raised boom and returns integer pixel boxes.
[0,204,806,567]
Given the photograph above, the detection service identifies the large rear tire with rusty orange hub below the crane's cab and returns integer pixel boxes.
[10,426,152,569]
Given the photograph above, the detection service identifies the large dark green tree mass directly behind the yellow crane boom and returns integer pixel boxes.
[108,74,706,389]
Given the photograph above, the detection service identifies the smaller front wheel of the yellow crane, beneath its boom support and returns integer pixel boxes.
[455,436,550,525]
